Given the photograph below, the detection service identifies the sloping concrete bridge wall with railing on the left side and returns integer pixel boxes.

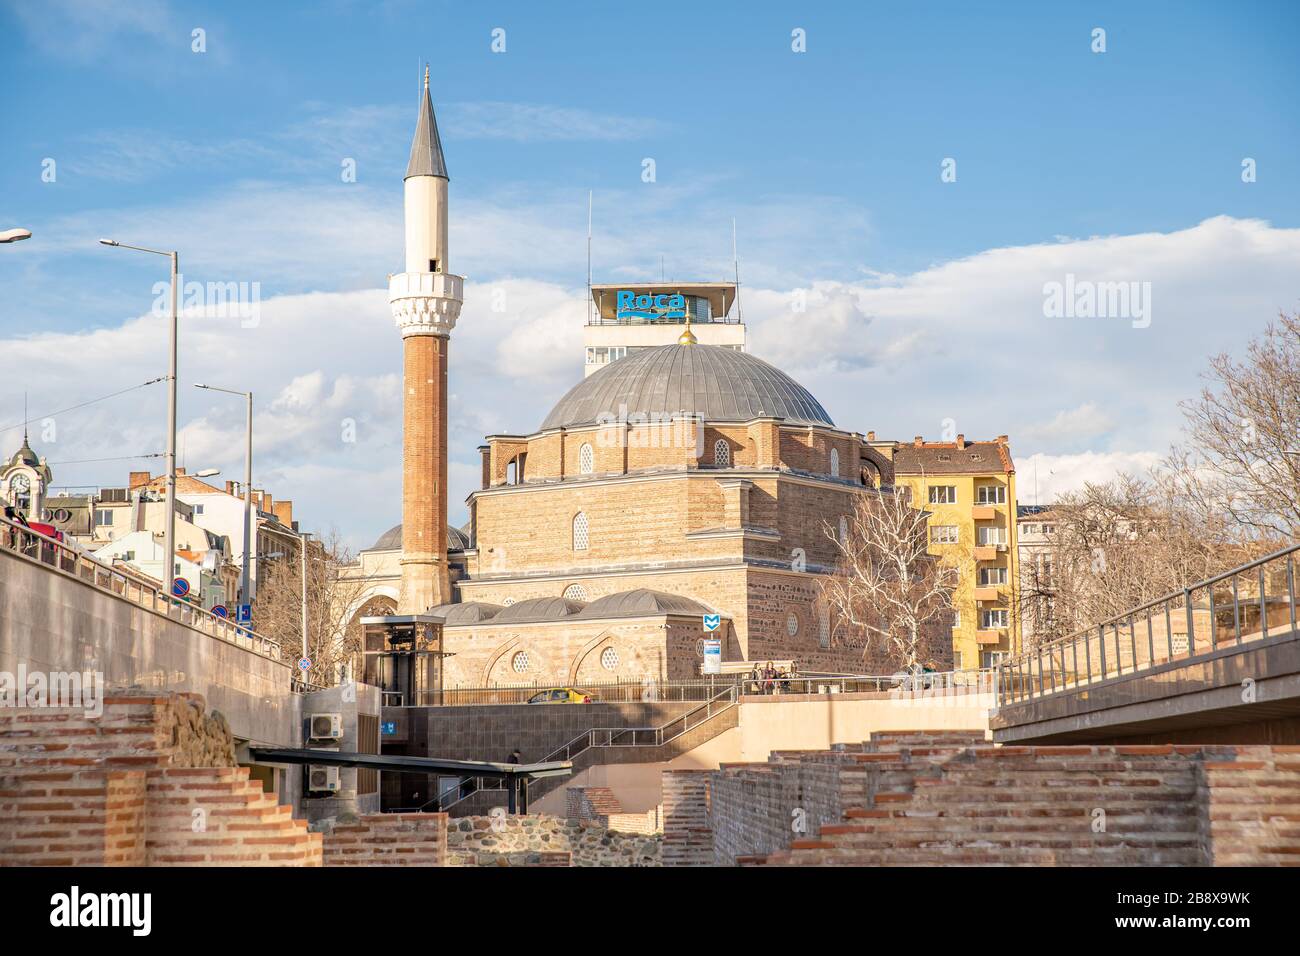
[0,519,302,747]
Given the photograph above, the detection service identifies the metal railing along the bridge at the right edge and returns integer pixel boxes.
[996,544,1300,706]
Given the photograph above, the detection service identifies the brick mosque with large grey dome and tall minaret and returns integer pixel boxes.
[348,74,945,687]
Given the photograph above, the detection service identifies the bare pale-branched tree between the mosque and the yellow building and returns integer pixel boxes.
[820,490,959,670]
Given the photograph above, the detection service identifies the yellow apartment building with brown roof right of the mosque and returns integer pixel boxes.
[867,433,1019,670]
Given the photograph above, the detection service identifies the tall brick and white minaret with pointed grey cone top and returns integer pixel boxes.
[389,66,464,614]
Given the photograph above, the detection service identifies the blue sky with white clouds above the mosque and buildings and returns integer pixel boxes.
[0,0,1300,548]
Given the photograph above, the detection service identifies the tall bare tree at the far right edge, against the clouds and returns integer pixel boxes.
[1166,313,1300,538]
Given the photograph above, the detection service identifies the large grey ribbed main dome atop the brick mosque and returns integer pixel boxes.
[541,343,835,432]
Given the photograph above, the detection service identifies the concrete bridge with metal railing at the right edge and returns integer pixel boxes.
[991,545,1300,744]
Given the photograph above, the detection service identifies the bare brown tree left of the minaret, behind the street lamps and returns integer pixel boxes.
[254,532,367,685]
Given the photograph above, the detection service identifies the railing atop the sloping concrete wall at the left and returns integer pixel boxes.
[0,518,280,661]
